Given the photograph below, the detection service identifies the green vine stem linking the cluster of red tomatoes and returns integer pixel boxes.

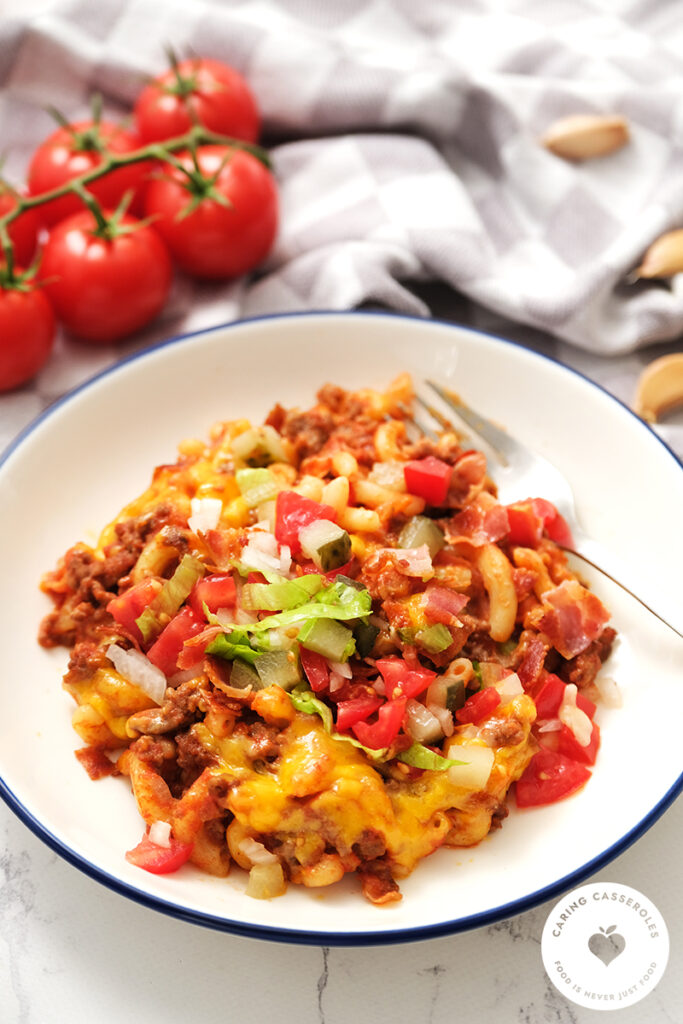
[0,125,270,281]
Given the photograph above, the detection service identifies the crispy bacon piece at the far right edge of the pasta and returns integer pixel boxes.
[540,580,609,658]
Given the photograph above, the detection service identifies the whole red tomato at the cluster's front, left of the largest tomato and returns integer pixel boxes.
[40,210,172,344]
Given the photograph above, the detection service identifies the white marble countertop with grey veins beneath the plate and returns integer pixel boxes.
[0,288,683,1024]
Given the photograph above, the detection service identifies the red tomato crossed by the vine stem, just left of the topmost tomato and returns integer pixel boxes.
[29,121,152,225]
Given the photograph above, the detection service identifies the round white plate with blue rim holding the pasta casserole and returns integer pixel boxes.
[0,313,683,945]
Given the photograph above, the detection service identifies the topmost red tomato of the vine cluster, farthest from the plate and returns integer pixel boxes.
[135,57,261,142]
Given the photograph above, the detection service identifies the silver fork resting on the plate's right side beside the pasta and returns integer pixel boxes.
[417,380,683,639]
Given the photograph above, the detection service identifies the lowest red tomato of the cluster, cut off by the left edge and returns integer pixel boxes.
[0,276,55,391]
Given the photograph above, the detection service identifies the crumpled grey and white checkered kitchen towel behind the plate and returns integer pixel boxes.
[0,0,683,372]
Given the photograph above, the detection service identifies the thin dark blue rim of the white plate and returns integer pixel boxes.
[0,309,683,946]
